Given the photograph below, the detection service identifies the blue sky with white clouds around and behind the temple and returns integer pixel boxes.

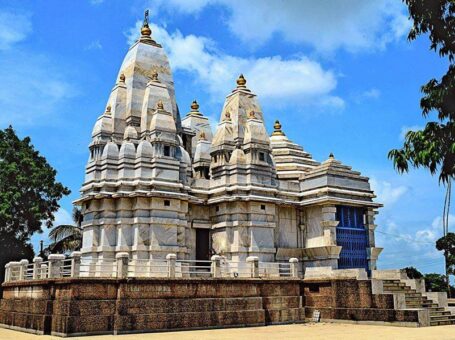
[0,0,455,272]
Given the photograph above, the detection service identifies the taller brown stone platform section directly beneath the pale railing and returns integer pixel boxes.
[0,278,304,336]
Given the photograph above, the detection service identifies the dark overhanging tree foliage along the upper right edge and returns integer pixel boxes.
[389,0,455,183]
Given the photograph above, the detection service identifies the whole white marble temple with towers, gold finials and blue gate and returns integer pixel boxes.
[77,13,381,270]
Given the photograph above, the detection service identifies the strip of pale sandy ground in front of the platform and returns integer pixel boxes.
[0,323,455,340]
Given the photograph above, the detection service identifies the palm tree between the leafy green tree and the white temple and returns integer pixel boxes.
[47,208,84,254]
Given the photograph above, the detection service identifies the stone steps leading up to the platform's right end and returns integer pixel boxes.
[383,280,455,326]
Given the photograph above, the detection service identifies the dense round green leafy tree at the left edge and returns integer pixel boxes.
[0,126,70,282]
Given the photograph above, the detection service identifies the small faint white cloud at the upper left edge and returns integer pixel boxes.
[0,11,32,50]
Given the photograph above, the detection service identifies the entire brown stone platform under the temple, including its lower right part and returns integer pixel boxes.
[0,278,427,336]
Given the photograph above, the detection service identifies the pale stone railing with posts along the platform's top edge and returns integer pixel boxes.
[5,252,299,282]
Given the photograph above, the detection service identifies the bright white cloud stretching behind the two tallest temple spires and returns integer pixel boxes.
[126,21,344,109]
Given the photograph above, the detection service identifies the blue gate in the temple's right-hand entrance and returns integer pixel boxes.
[337,206,369,272]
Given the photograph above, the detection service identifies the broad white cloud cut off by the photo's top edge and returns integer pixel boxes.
[151,0,410,52]
